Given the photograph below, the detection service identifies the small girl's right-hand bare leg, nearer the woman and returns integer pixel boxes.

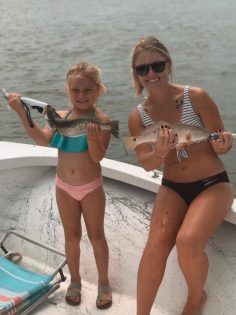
[81,186,110,305]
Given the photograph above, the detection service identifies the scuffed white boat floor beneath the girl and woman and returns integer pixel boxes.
[0,167,236,315]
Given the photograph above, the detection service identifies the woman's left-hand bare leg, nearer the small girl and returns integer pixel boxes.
[137,186,187,315]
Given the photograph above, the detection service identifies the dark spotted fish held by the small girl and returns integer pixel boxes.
[43,105,119,139]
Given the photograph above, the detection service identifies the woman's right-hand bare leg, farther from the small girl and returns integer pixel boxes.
[176,183,233,315]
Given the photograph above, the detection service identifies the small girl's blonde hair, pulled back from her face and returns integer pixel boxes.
[66,62,106,94]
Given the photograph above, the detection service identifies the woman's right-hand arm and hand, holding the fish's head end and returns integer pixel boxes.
[189,87,233,154]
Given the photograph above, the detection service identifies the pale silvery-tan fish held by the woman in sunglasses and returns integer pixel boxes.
[121,121,236,151]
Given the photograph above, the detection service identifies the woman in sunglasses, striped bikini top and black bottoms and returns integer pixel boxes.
[129,37,233,315]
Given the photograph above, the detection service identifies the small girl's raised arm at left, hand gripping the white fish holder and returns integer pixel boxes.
[7,93,54,146]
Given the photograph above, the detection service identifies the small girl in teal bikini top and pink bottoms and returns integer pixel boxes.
[8,62,112,309]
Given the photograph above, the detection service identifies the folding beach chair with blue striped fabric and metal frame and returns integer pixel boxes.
[0,230,66,315]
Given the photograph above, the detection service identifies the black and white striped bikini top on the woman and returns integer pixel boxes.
[137,85,204,161]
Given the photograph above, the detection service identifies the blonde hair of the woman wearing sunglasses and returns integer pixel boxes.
[131,36,172,96]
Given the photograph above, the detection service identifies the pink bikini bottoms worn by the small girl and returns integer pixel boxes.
[56,175,103,201]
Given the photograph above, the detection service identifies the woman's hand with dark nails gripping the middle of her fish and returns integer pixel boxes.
[154,126,178,159]
